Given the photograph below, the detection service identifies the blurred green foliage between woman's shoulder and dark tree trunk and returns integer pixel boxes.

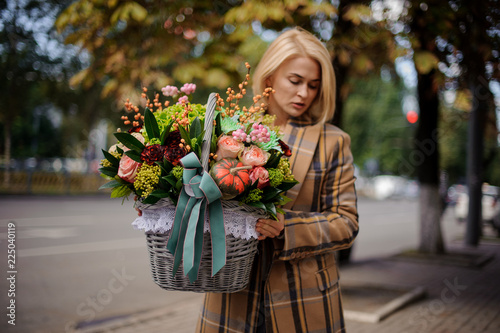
[343,76,413,176]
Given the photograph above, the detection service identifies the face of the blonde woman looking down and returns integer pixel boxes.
[267,57,321,125]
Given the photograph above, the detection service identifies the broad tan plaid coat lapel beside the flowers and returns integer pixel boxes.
[283,123,323,209]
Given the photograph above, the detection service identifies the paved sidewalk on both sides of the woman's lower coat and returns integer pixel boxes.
[76,237,500,333]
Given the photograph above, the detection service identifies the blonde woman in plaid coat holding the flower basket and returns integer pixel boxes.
[197,28,358,333]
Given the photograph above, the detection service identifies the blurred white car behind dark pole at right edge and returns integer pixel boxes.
[455,184,500,230]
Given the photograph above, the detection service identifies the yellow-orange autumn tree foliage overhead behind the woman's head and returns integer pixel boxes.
[57,0,398,124]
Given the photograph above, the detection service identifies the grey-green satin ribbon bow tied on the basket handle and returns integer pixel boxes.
[167,153,226,283]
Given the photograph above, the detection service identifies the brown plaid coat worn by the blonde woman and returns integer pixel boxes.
[197,120,358,333]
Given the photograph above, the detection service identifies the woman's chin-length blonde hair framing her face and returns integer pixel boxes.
[252,27,336,123]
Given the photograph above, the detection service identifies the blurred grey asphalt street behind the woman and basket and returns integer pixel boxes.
[0,195,464,332]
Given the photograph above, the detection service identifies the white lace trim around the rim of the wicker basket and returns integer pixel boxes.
[132,203,266,240]
